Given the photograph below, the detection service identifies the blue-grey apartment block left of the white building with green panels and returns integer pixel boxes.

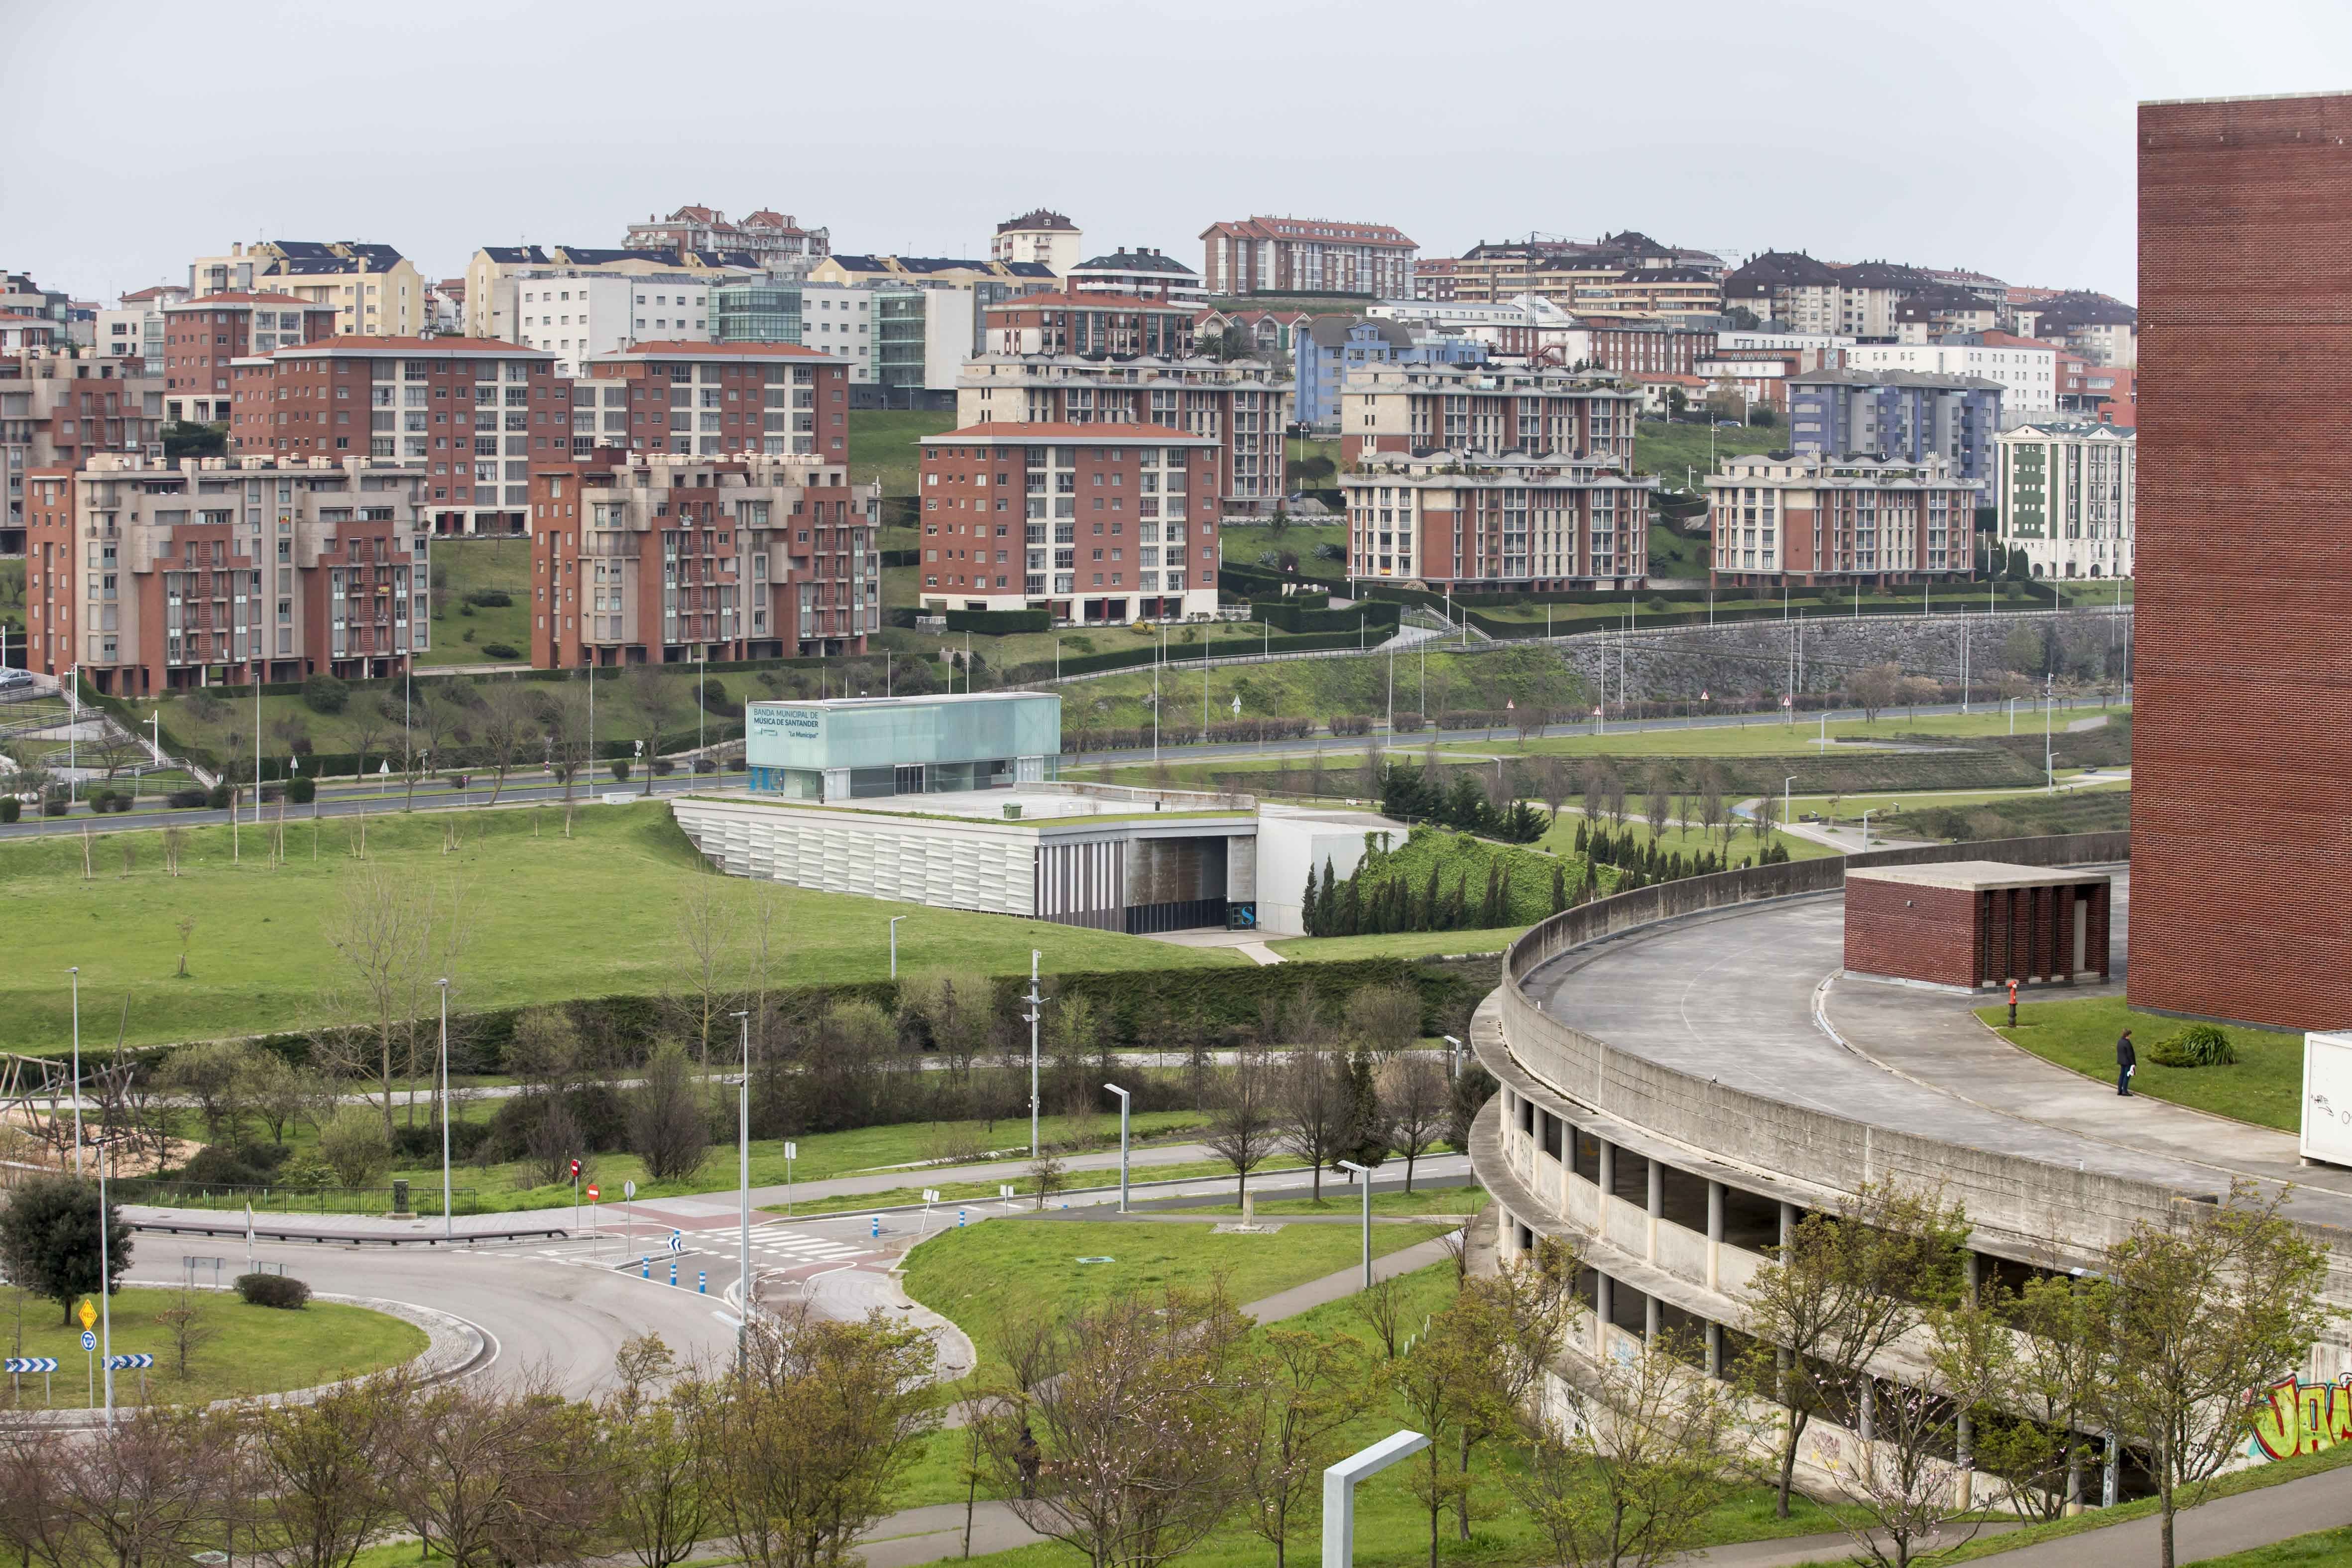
[1787,369,2001,493]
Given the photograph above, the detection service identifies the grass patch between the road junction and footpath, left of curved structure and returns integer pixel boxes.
[906,1215,1444,1366]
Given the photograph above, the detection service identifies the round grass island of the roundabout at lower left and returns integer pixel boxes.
[0,1288,426,1408]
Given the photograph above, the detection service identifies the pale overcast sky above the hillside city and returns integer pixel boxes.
[0,0,2352,301]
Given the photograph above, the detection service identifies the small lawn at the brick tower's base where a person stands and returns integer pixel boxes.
[1976,997,2303,1133]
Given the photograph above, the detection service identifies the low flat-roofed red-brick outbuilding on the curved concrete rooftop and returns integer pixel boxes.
[1846,860,2110,990]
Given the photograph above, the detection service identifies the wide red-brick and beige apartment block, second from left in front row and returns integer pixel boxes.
[532,447,882,670]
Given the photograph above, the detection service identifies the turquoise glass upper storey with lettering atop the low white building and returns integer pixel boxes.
[743,691,1061,802]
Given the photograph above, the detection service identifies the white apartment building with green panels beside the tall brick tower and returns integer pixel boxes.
[1997,421,2138,578]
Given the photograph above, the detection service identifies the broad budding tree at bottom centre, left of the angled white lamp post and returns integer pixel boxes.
[974,1293,1256,1568]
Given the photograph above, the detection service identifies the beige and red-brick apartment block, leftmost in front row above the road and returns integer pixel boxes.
[26,454,430,696]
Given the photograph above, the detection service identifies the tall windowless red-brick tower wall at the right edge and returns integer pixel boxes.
[2126,94,2352,1030]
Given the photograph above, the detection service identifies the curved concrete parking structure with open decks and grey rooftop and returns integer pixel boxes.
[1470,835,2352,1502]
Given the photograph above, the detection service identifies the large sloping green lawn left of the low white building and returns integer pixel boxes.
[0,802,1247,1051]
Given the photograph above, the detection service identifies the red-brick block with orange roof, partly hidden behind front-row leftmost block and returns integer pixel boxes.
[228,336,574,534]
